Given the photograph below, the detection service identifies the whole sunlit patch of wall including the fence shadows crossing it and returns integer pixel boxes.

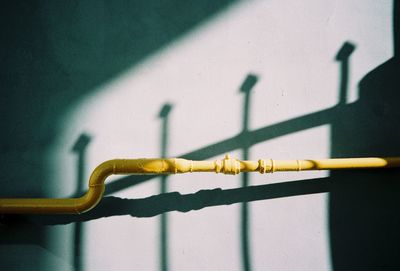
[0,0,394,271]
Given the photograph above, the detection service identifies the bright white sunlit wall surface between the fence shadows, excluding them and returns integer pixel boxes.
[48,0,392,271]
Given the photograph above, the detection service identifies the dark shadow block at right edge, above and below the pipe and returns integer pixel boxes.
[329,1,400,270]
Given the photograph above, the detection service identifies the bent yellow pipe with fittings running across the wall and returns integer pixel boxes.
[0,155,400,214]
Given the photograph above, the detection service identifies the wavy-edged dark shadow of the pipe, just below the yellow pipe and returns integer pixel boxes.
[36,177,334,225]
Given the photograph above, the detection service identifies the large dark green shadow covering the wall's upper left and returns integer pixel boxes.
[0,0,233,270]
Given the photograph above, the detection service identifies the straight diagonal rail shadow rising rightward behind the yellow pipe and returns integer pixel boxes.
[105,104,351,195]
